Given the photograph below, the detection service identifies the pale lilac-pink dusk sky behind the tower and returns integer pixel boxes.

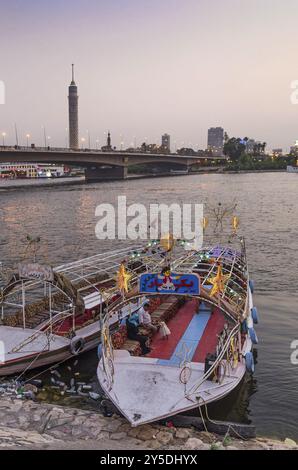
[0,0,298,149]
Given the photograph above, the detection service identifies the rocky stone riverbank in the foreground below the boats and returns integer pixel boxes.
[0,398,298,450]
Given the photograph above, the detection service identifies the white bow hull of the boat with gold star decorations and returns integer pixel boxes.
[97,351,246,427]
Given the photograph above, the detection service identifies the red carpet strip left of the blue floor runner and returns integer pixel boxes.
[146,299,198,359]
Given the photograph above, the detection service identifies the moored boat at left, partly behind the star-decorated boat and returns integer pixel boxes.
[0,246,148,376]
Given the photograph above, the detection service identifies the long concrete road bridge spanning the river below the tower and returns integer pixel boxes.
[0,146,225,182]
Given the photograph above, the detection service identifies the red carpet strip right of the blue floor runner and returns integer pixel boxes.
[192,308,225,362]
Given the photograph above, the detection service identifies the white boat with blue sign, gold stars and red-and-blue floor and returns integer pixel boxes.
[97,224,258,427]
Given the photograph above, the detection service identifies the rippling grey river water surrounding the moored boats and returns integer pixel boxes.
[0,173,298,439]
